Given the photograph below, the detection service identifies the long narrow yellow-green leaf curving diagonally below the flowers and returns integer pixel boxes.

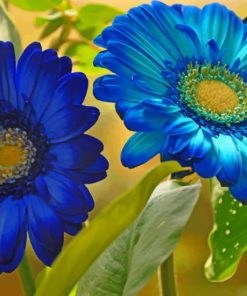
[36,162,183,296]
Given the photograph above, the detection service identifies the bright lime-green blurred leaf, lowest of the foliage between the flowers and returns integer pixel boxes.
[65,41,106,74]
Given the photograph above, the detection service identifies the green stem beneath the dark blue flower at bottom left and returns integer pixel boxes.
[18,254,35,296]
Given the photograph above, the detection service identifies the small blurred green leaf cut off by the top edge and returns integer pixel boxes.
[8,0,63,11]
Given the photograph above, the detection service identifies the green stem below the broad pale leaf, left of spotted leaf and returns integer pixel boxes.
[160,254,177,296]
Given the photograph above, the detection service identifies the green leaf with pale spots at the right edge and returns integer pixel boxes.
[205,184,247,282]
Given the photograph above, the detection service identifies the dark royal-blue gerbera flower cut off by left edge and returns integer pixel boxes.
[0,42,108,272]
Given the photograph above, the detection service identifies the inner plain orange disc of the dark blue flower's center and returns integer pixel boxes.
[0,144,25,168]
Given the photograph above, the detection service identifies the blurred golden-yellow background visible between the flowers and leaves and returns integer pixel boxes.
[0,0,247,296]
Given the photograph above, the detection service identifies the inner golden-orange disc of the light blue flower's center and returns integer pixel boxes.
[196,80,239,114]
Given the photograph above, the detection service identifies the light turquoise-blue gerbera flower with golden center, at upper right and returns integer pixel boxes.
[94,1,247,203]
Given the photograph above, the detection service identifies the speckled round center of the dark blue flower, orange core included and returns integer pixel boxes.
[0,128,36,185]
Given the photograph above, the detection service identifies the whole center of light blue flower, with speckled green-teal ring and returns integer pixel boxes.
[177,62,247,126]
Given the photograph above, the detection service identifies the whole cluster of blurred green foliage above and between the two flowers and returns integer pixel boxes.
[32,4,121,74]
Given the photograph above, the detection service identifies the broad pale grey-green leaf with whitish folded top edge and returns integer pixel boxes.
[76,181,201,296]
